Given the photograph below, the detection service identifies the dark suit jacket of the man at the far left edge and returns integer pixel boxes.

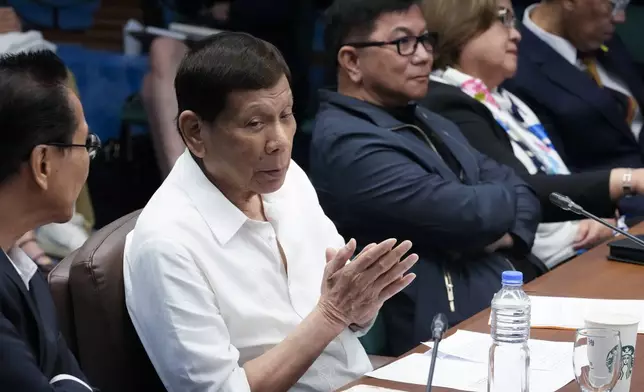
[0,252,93,392]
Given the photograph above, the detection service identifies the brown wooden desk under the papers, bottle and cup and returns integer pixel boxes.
[345,224,644,392]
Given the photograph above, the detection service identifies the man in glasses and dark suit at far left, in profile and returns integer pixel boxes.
[0,51,99,392]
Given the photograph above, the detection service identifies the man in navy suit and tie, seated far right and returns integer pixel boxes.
[504,0,644,214]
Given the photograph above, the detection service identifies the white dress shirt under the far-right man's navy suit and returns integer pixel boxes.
[523,4,644,139]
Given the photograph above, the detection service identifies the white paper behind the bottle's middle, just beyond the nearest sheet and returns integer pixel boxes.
[428,329,574,376]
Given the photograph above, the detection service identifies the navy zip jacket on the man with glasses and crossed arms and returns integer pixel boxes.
[311,91,540,355]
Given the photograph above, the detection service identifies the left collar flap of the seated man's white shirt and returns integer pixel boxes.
[168,149,248,245]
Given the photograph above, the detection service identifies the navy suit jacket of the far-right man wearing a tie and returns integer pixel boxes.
[504,26,644,171]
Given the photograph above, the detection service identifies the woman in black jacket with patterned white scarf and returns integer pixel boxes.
[421,0,644,267]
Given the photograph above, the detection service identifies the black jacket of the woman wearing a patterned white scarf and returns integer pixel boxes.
[420,81,616,222]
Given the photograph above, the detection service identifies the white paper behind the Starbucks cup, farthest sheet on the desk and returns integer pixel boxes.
[530,296,644,333]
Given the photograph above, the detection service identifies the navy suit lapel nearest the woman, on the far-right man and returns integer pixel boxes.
[520,27,635,140]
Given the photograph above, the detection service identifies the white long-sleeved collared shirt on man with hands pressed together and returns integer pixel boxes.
[123,151,371,392]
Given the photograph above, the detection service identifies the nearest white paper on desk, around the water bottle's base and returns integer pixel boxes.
[367,354,574,392]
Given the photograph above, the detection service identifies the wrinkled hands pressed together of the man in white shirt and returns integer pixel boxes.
[318,239,418,327]
